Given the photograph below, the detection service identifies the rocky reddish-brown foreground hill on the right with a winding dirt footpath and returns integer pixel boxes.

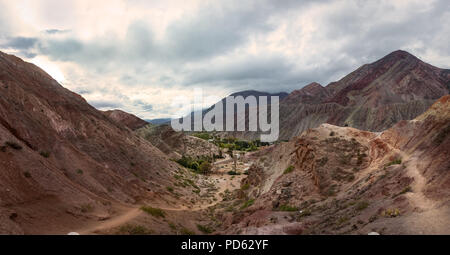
[215,95,450,234]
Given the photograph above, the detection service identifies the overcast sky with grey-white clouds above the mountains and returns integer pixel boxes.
[0,0,450,119]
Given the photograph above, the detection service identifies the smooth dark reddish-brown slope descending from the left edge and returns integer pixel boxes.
[0,52,188,234]
